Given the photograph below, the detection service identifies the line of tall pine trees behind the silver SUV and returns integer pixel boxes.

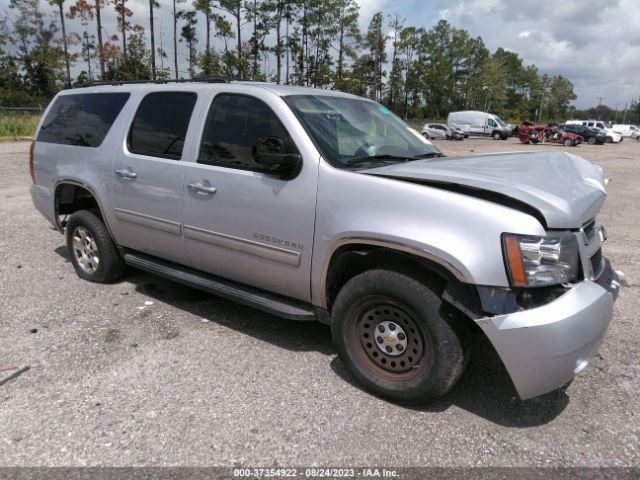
[0,0,640,121]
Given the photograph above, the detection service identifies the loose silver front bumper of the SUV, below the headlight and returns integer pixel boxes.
[477,262,619,400]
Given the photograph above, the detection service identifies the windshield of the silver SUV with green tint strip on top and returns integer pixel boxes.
[284,95,442,168]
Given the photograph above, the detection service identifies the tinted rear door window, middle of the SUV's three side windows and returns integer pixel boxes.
[129,92,197,160]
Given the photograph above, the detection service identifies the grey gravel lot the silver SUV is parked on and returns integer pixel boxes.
[0,139,640,466]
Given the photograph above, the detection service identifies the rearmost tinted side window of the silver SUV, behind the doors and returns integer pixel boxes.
[36,93,129,147]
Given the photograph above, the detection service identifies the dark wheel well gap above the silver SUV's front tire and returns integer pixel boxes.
[325,244,482,316]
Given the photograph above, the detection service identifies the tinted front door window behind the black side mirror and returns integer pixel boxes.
[198,94,295,171]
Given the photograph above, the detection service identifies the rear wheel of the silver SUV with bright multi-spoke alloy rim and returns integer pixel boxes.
[65,210,124,283]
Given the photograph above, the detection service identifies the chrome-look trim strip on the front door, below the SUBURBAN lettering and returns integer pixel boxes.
[183,225,301,267]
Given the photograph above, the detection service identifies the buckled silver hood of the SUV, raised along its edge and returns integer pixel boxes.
[362,151,607,229]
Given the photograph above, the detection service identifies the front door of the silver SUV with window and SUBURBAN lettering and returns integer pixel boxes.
[184,93,318,301]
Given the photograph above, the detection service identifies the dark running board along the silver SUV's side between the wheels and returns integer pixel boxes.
[124,253,317,321]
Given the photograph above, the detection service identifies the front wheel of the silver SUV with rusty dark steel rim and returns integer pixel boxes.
[331,270,465,403]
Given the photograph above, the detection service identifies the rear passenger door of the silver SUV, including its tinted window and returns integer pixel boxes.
[110,91,197,264]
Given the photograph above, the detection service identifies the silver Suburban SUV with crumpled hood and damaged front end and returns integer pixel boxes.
[30,82,618,402]
